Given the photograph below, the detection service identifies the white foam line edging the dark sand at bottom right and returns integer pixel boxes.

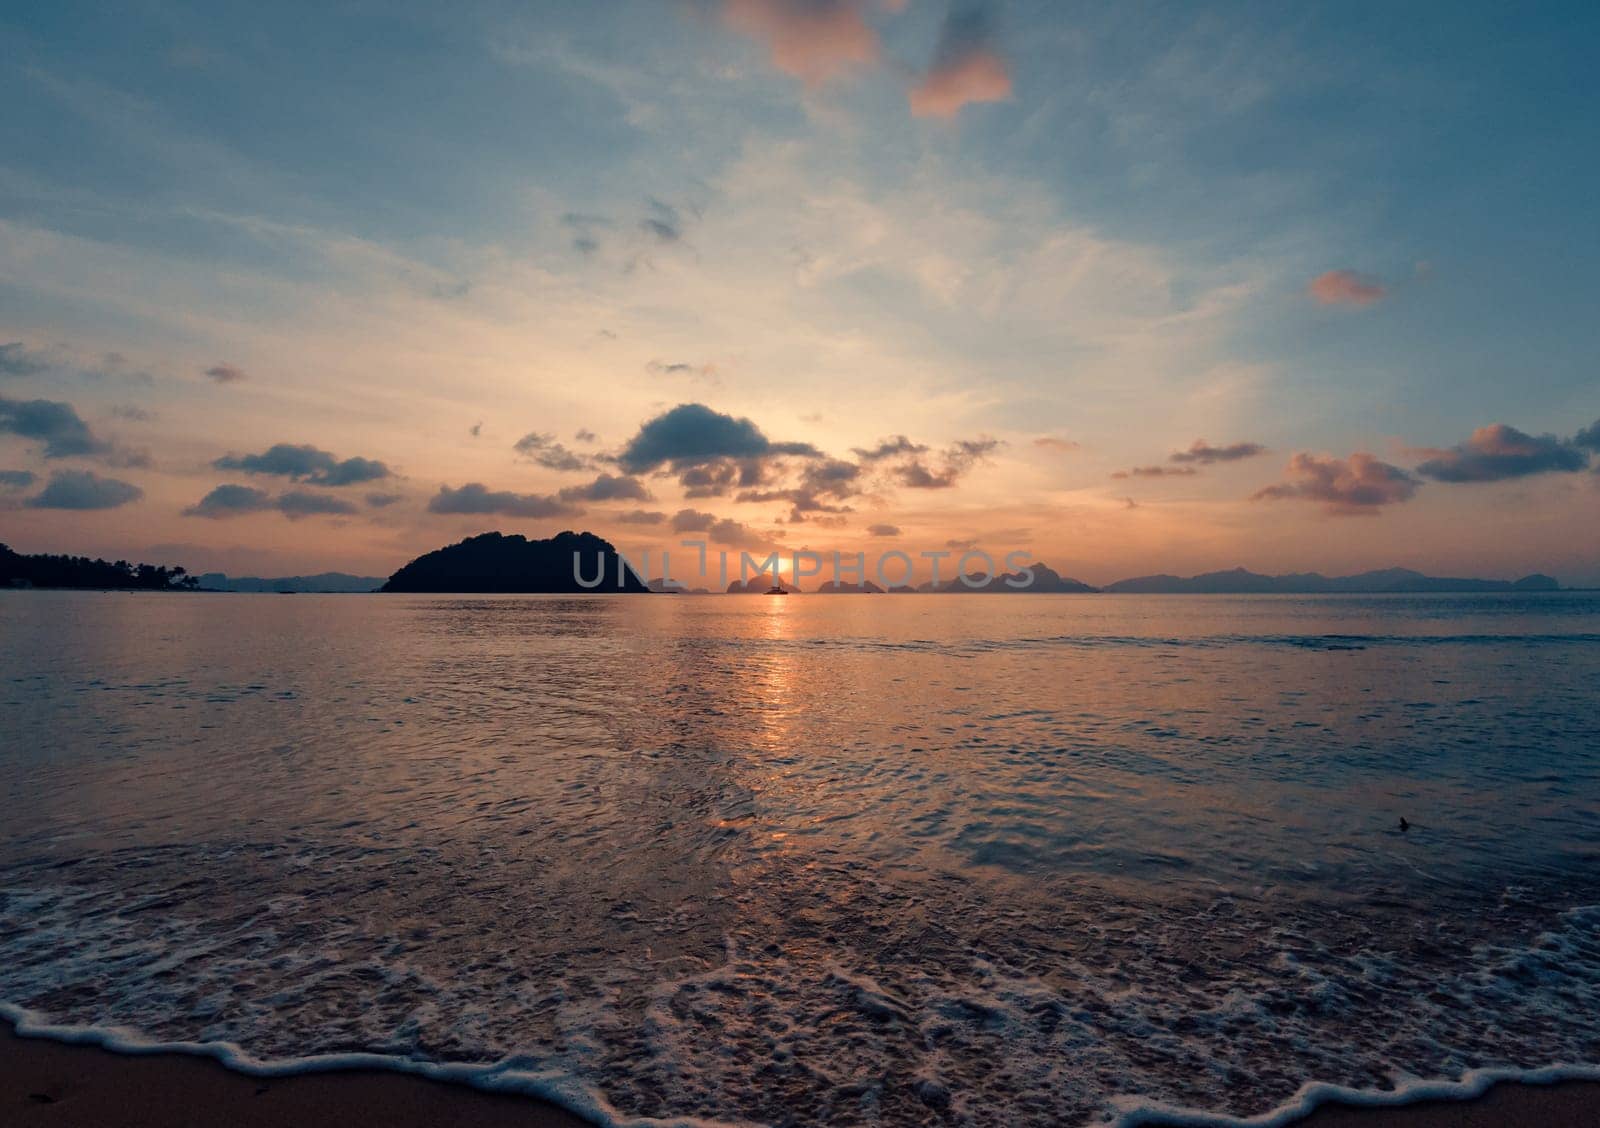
[1110,1064,1600,1128]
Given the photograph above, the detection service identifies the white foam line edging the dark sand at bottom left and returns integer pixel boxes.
[0,1003,750,1128]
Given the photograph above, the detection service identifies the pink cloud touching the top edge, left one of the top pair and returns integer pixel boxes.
[722,0,878,86]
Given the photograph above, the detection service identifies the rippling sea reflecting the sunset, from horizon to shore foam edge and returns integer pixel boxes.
[0,592,1600,1125]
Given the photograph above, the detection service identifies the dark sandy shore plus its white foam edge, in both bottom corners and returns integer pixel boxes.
[0,1008,1600,1128]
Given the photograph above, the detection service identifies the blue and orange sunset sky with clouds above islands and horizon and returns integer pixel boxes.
[0,0,1600,584]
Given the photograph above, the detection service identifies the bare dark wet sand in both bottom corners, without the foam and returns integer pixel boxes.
[0,1024,1600,1128]
